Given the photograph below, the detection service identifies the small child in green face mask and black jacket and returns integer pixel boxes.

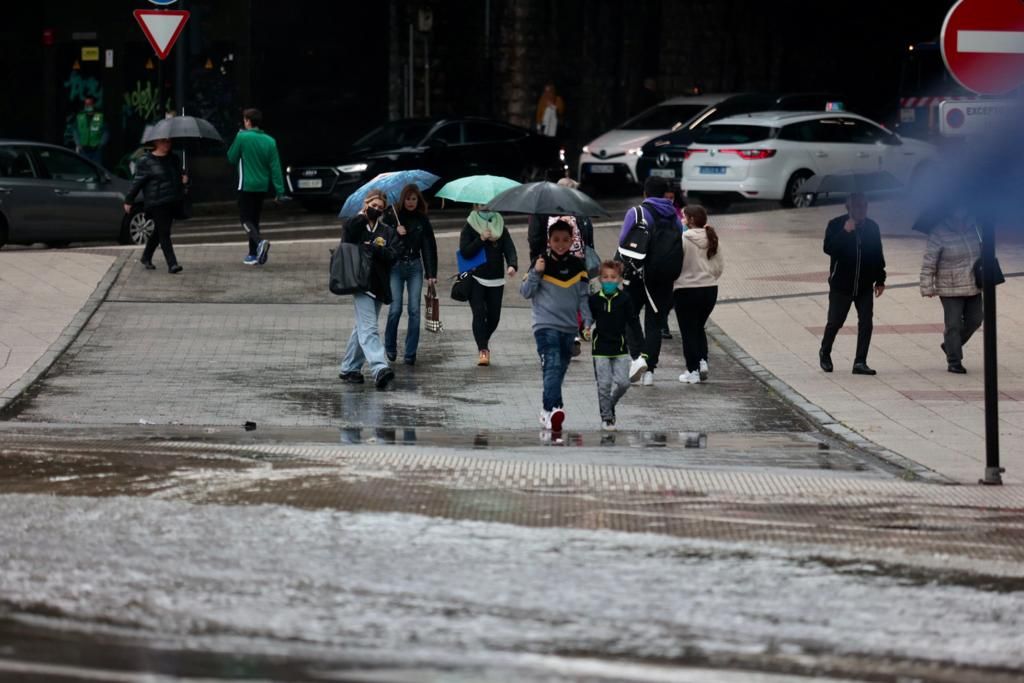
[590,261,643,431]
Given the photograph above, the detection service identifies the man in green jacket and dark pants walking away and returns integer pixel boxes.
[227,109,285,265]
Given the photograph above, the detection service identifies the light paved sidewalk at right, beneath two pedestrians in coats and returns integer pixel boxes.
[696,202,1024,483]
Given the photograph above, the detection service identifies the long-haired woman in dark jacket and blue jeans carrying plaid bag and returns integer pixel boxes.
[384,184,437,366]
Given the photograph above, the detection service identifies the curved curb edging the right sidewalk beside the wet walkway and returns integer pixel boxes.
[708,321,959,485]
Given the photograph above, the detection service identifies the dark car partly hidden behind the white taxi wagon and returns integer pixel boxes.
[636,92,845,184]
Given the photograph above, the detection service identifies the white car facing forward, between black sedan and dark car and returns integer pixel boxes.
[578,94,730,189]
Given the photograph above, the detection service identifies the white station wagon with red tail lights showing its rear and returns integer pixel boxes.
[682,112,936,207]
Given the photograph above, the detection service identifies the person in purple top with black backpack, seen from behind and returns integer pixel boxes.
[616,176,684,386]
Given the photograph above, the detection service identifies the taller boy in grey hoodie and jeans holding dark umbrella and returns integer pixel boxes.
[519,221,594,432]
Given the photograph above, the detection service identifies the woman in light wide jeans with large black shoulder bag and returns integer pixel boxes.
[339,189,395,389]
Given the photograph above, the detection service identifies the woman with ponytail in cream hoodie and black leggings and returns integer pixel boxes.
[673,206,725,384]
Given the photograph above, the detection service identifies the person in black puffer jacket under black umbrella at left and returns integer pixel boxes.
[125,139,188,272]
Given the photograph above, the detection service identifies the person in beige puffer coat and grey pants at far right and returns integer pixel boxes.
[921,216,982,375]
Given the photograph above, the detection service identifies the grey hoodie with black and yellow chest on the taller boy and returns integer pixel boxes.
[519,254,594,333]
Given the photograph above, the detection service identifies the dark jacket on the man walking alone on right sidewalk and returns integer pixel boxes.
[822,214,886,296]
